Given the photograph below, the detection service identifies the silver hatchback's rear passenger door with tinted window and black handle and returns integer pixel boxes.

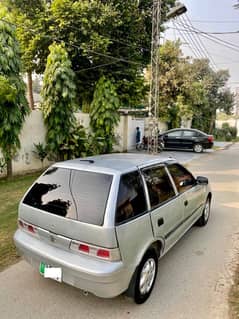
[142,165,184,251]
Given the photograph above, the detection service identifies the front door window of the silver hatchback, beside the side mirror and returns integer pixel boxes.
[168,164,196,193]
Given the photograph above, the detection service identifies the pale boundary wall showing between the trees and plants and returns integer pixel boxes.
[0,110,167,174]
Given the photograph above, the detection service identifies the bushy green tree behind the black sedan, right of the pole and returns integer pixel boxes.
[148,41,233,133]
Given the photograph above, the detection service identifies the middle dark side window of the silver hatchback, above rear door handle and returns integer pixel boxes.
[143,166,175,208]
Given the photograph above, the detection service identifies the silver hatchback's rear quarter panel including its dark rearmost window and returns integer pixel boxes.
[115,170,153,272]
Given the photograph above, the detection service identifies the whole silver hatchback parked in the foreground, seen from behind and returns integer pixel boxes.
[14,154,212,304]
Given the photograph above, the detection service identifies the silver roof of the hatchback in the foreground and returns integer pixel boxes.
[53,153,176,174]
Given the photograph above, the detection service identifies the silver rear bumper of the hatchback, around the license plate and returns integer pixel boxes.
[14,229,133,298]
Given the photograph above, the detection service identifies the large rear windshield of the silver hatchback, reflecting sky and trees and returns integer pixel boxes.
[23,167,112,225]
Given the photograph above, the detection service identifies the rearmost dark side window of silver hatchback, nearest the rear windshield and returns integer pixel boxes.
[116,171,147,223]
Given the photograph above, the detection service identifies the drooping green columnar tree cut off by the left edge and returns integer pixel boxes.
[0,11,29,177]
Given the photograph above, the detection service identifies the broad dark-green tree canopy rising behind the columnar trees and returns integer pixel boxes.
[5,0,175,109]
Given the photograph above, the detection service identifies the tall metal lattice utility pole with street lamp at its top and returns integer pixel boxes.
[148,0,187,153]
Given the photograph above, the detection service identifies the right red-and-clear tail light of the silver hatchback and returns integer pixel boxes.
[70,240,121,261]
